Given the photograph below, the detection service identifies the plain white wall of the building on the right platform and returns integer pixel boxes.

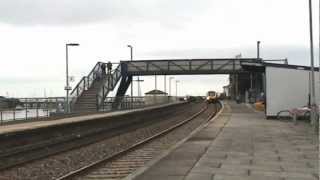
[266,66,320,116]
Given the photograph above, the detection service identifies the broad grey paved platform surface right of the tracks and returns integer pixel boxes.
[134,102,319,180]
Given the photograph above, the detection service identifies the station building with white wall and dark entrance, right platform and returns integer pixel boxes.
[228,62,320,118]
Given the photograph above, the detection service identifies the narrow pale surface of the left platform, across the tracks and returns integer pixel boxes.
[0,102,184,135]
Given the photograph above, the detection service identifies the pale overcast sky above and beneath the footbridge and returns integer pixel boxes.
[0,0,319,97]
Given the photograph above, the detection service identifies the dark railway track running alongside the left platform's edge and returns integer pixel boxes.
[0,102,195,171]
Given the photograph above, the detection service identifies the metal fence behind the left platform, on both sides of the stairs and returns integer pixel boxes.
[0,96,179,125]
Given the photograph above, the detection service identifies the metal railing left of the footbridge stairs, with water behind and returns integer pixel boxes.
[0,97,65,125]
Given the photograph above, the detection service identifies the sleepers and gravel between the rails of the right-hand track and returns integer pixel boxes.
[72,102,217,180]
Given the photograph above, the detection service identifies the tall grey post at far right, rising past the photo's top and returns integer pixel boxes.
[309,0,317,130]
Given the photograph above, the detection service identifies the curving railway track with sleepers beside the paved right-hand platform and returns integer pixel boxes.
[58,104,219,180]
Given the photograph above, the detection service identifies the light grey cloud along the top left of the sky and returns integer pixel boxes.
[0,0,211,25]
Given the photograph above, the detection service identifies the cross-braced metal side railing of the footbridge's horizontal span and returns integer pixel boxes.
[121,58,249,75]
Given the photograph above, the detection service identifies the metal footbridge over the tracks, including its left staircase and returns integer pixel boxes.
[71,58,263,112]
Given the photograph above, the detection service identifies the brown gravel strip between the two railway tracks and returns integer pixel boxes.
[0,104,203,180]
